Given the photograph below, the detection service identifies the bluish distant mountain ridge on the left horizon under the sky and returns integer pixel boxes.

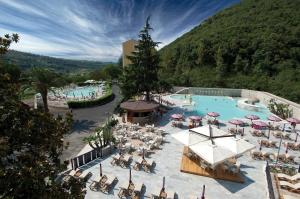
[4,50,108,72]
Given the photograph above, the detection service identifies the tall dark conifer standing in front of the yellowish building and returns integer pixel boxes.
[121,17,160,101]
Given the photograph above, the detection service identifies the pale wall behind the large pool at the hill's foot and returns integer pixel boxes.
[174,87,300,118]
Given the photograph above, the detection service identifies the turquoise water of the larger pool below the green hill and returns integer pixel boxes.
[171,94,271,121]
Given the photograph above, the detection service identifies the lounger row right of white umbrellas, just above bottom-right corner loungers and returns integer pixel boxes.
[251,151,296,164]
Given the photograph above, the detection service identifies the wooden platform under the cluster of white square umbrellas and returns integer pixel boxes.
[180,147,244,183]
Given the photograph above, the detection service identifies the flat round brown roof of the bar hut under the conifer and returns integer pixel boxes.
[120,100,159,112]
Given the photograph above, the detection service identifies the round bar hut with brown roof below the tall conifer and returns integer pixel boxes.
[120,100,159,124]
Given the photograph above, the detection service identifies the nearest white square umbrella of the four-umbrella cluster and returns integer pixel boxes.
[189,140,235,167]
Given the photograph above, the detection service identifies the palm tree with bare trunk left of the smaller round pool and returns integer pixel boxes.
[28,67,63,112]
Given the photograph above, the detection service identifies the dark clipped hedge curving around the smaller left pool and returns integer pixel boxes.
[68,90,115,108]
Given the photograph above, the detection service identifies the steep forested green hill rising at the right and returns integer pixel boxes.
[160,0,300,102]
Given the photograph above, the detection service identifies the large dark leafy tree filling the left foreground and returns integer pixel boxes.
[0,33,84,199]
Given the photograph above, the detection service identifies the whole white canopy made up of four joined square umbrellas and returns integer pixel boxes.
[172,125,255,167]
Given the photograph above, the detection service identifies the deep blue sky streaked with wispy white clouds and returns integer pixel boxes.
[0,0,239,61]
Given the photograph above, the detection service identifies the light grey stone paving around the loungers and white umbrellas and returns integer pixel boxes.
[82,95,299,199]
